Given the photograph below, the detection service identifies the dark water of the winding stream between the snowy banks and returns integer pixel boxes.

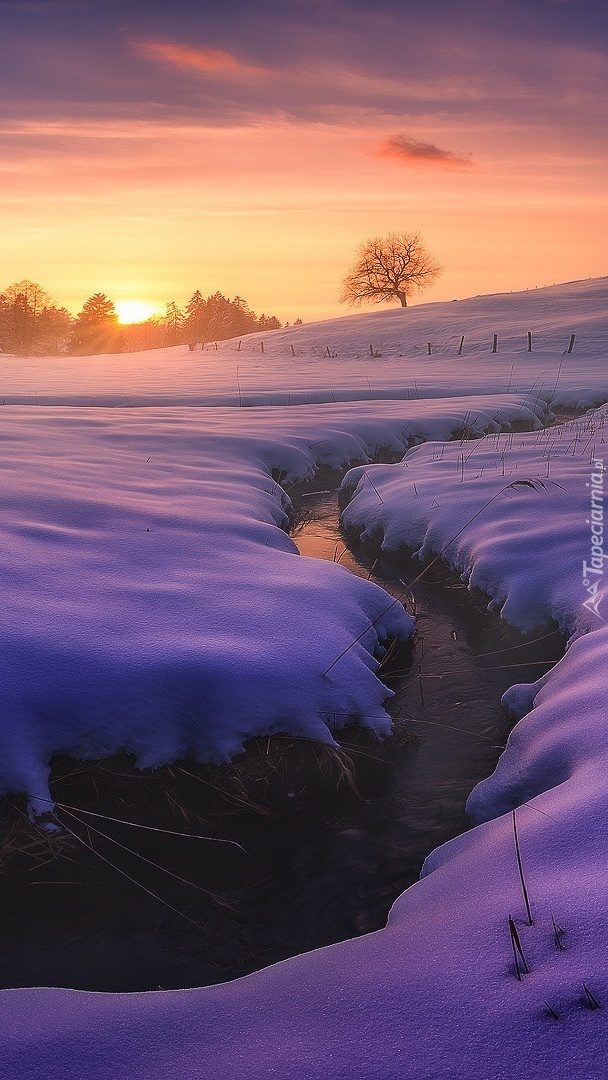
[0,492,562,990]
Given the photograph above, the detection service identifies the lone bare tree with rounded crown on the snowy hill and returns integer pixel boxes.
[340,232,442,308]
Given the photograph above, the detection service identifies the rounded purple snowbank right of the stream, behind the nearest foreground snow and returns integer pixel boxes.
[341,408,608,636]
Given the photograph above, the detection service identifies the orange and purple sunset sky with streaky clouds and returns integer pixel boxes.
[0,0,608,322]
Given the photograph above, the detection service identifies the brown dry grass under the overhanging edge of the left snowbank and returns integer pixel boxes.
[0,718,416,877]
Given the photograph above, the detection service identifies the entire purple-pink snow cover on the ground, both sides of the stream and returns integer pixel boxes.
[0,281,608,1080]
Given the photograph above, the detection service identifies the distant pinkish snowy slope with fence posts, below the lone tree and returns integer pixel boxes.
[0,278,608,408]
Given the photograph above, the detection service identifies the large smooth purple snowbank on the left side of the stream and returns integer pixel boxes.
[0,395,552,807]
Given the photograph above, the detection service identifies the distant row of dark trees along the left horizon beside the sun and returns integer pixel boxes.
[0,281,287,356]
